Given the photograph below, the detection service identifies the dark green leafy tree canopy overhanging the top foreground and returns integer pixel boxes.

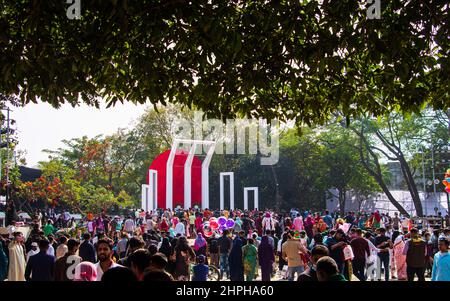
[0,0,450,124]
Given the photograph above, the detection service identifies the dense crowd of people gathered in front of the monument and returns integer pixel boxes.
[0,208,450,281]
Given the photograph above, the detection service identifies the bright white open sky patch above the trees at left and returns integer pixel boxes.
[10,102,147,167]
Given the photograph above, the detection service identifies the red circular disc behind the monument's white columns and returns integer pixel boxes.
[147,150,202,208]
